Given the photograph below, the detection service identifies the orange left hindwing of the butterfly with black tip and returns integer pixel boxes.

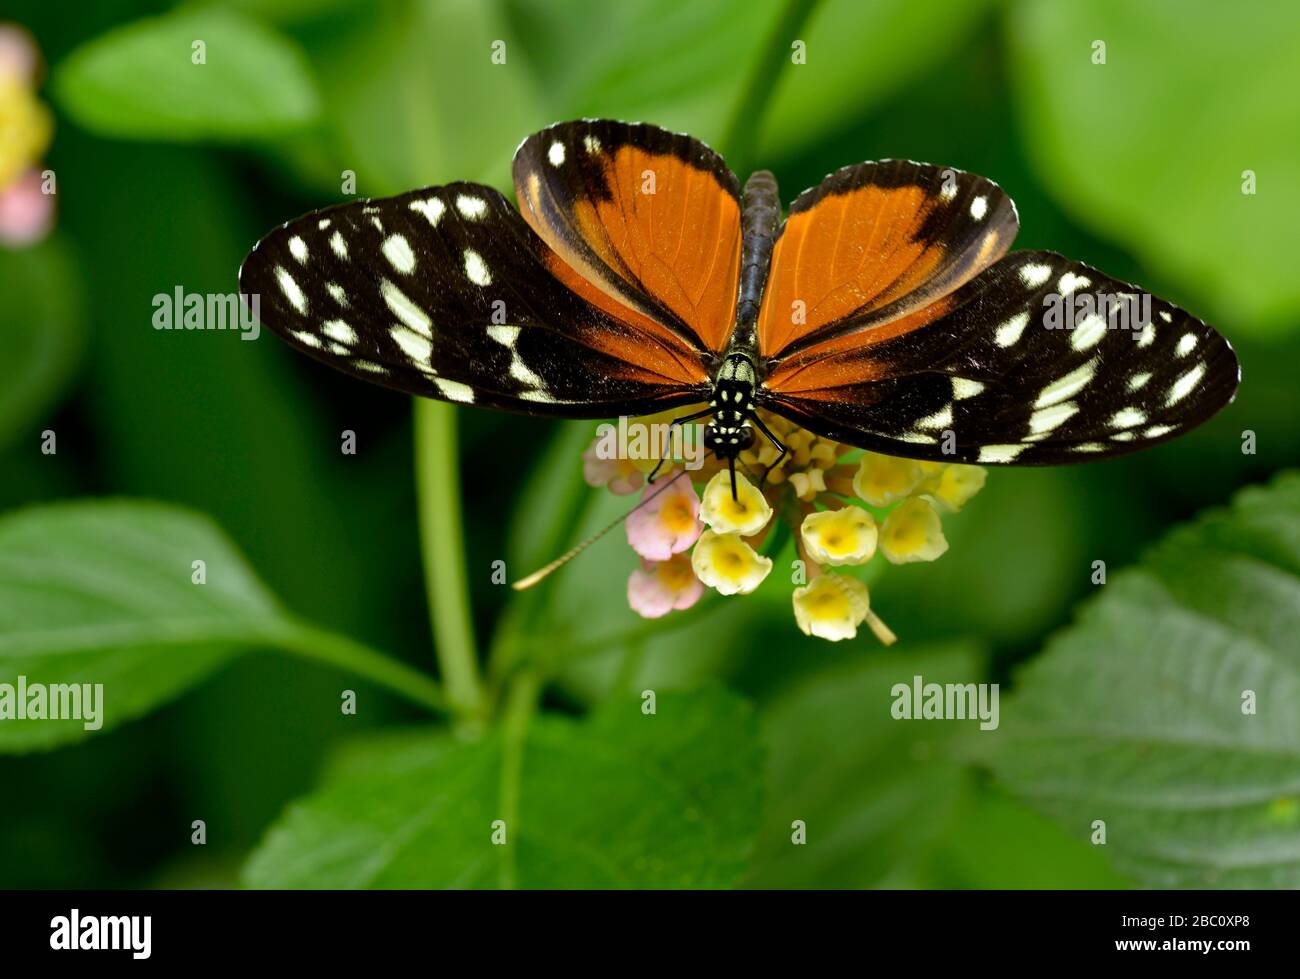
[514,120,741,356]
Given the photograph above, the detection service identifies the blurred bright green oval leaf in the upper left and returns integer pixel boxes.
[55,7,320,142]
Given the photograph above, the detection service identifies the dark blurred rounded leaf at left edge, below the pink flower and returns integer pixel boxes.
[0,238,85,451]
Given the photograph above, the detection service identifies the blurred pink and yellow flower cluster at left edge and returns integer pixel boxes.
[0,23,55,247]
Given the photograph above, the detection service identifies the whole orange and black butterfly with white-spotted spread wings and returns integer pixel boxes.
[239,121,1239,488]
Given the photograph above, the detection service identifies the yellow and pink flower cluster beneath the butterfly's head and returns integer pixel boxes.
[584,412,985,645]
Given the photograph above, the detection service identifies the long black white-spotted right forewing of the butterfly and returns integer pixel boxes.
[764,251,1240,465]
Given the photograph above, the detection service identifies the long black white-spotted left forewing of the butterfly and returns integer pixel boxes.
[239,183,709,417]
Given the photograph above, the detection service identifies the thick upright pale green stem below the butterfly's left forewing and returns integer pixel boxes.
[415,398,485,722]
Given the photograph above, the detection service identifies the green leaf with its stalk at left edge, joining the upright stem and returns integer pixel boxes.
[0,501,441,751]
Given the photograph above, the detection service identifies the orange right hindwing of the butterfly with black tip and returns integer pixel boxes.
[758,160,1018,361]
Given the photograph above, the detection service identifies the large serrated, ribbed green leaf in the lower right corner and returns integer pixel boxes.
[992,473,1300,887]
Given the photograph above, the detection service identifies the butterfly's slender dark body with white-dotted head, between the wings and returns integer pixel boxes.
[705,170,781,459]
